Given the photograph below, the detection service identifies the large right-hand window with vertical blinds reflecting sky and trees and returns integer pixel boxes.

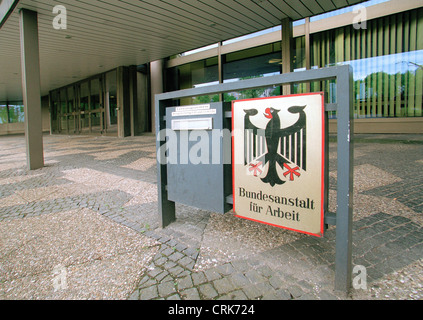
[311,8,423,118]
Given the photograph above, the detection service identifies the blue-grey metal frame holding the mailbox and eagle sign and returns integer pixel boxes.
[155,65,354,293]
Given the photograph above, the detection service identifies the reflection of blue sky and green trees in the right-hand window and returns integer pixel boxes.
[340,50,423,117]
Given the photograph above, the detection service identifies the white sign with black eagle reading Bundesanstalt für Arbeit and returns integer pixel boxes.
[232,92,325,237]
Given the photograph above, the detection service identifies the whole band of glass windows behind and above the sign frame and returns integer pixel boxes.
[167,8,423,118]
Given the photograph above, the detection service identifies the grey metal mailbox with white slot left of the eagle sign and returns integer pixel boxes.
[165,102,232,213]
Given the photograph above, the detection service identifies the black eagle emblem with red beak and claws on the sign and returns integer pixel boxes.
[244,106,306,187]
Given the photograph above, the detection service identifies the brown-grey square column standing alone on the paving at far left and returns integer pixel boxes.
[19,9,44,170]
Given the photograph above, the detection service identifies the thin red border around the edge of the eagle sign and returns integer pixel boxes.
[231,92,326,238]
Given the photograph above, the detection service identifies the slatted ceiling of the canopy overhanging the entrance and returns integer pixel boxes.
[0,0,363,101]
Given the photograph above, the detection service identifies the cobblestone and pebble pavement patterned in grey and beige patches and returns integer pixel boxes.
[0,135,423,300]
